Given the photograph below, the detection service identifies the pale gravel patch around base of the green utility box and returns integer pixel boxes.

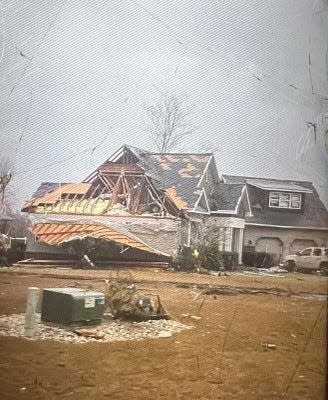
[0,314,192,343]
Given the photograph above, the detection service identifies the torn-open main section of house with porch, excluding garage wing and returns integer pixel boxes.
[22,146,244,260]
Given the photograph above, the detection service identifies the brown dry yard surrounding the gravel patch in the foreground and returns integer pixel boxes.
[0,268,327,400]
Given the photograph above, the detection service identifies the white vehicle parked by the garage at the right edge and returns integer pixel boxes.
[284,247,328,275]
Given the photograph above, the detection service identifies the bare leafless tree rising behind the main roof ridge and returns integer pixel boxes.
[146,94,194,153]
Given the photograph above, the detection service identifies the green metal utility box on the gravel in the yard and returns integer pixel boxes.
[41,288,105,325]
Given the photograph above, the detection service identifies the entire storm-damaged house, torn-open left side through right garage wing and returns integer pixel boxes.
[22,145,327,263]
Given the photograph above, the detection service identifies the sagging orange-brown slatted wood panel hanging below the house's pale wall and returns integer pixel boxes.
[31,222,166,255]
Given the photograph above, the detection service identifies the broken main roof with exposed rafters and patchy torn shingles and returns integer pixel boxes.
[22,146,213,216]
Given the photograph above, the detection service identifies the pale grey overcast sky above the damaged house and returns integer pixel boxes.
[0,0,328,206]
